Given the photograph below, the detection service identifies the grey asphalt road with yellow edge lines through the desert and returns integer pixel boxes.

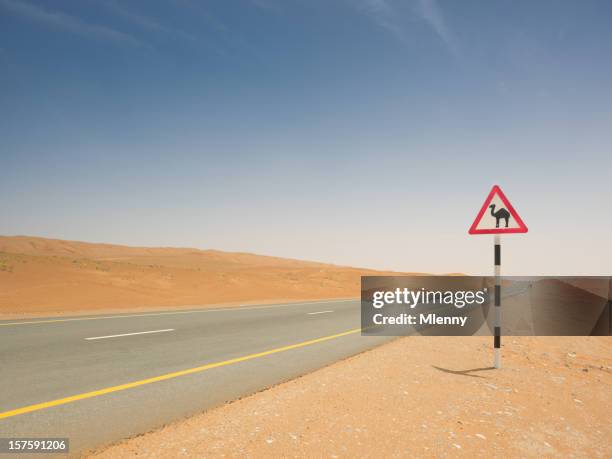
[0,300,392,457]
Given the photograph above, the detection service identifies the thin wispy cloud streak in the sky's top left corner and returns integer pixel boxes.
[0,0,146,47]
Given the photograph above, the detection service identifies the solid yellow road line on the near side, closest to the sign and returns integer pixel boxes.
[0,328,361,419]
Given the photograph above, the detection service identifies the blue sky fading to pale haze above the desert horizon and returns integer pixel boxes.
[0,0,612,275]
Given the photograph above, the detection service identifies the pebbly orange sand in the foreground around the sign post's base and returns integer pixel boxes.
[95,336,612,458]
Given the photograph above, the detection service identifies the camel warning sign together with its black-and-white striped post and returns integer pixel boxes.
[468,185,528,368]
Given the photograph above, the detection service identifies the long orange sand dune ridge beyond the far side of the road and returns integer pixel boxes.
[0,236,408,317]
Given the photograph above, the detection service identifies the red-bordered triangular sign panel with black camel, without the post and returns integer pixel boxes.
[468,185,527,234]
